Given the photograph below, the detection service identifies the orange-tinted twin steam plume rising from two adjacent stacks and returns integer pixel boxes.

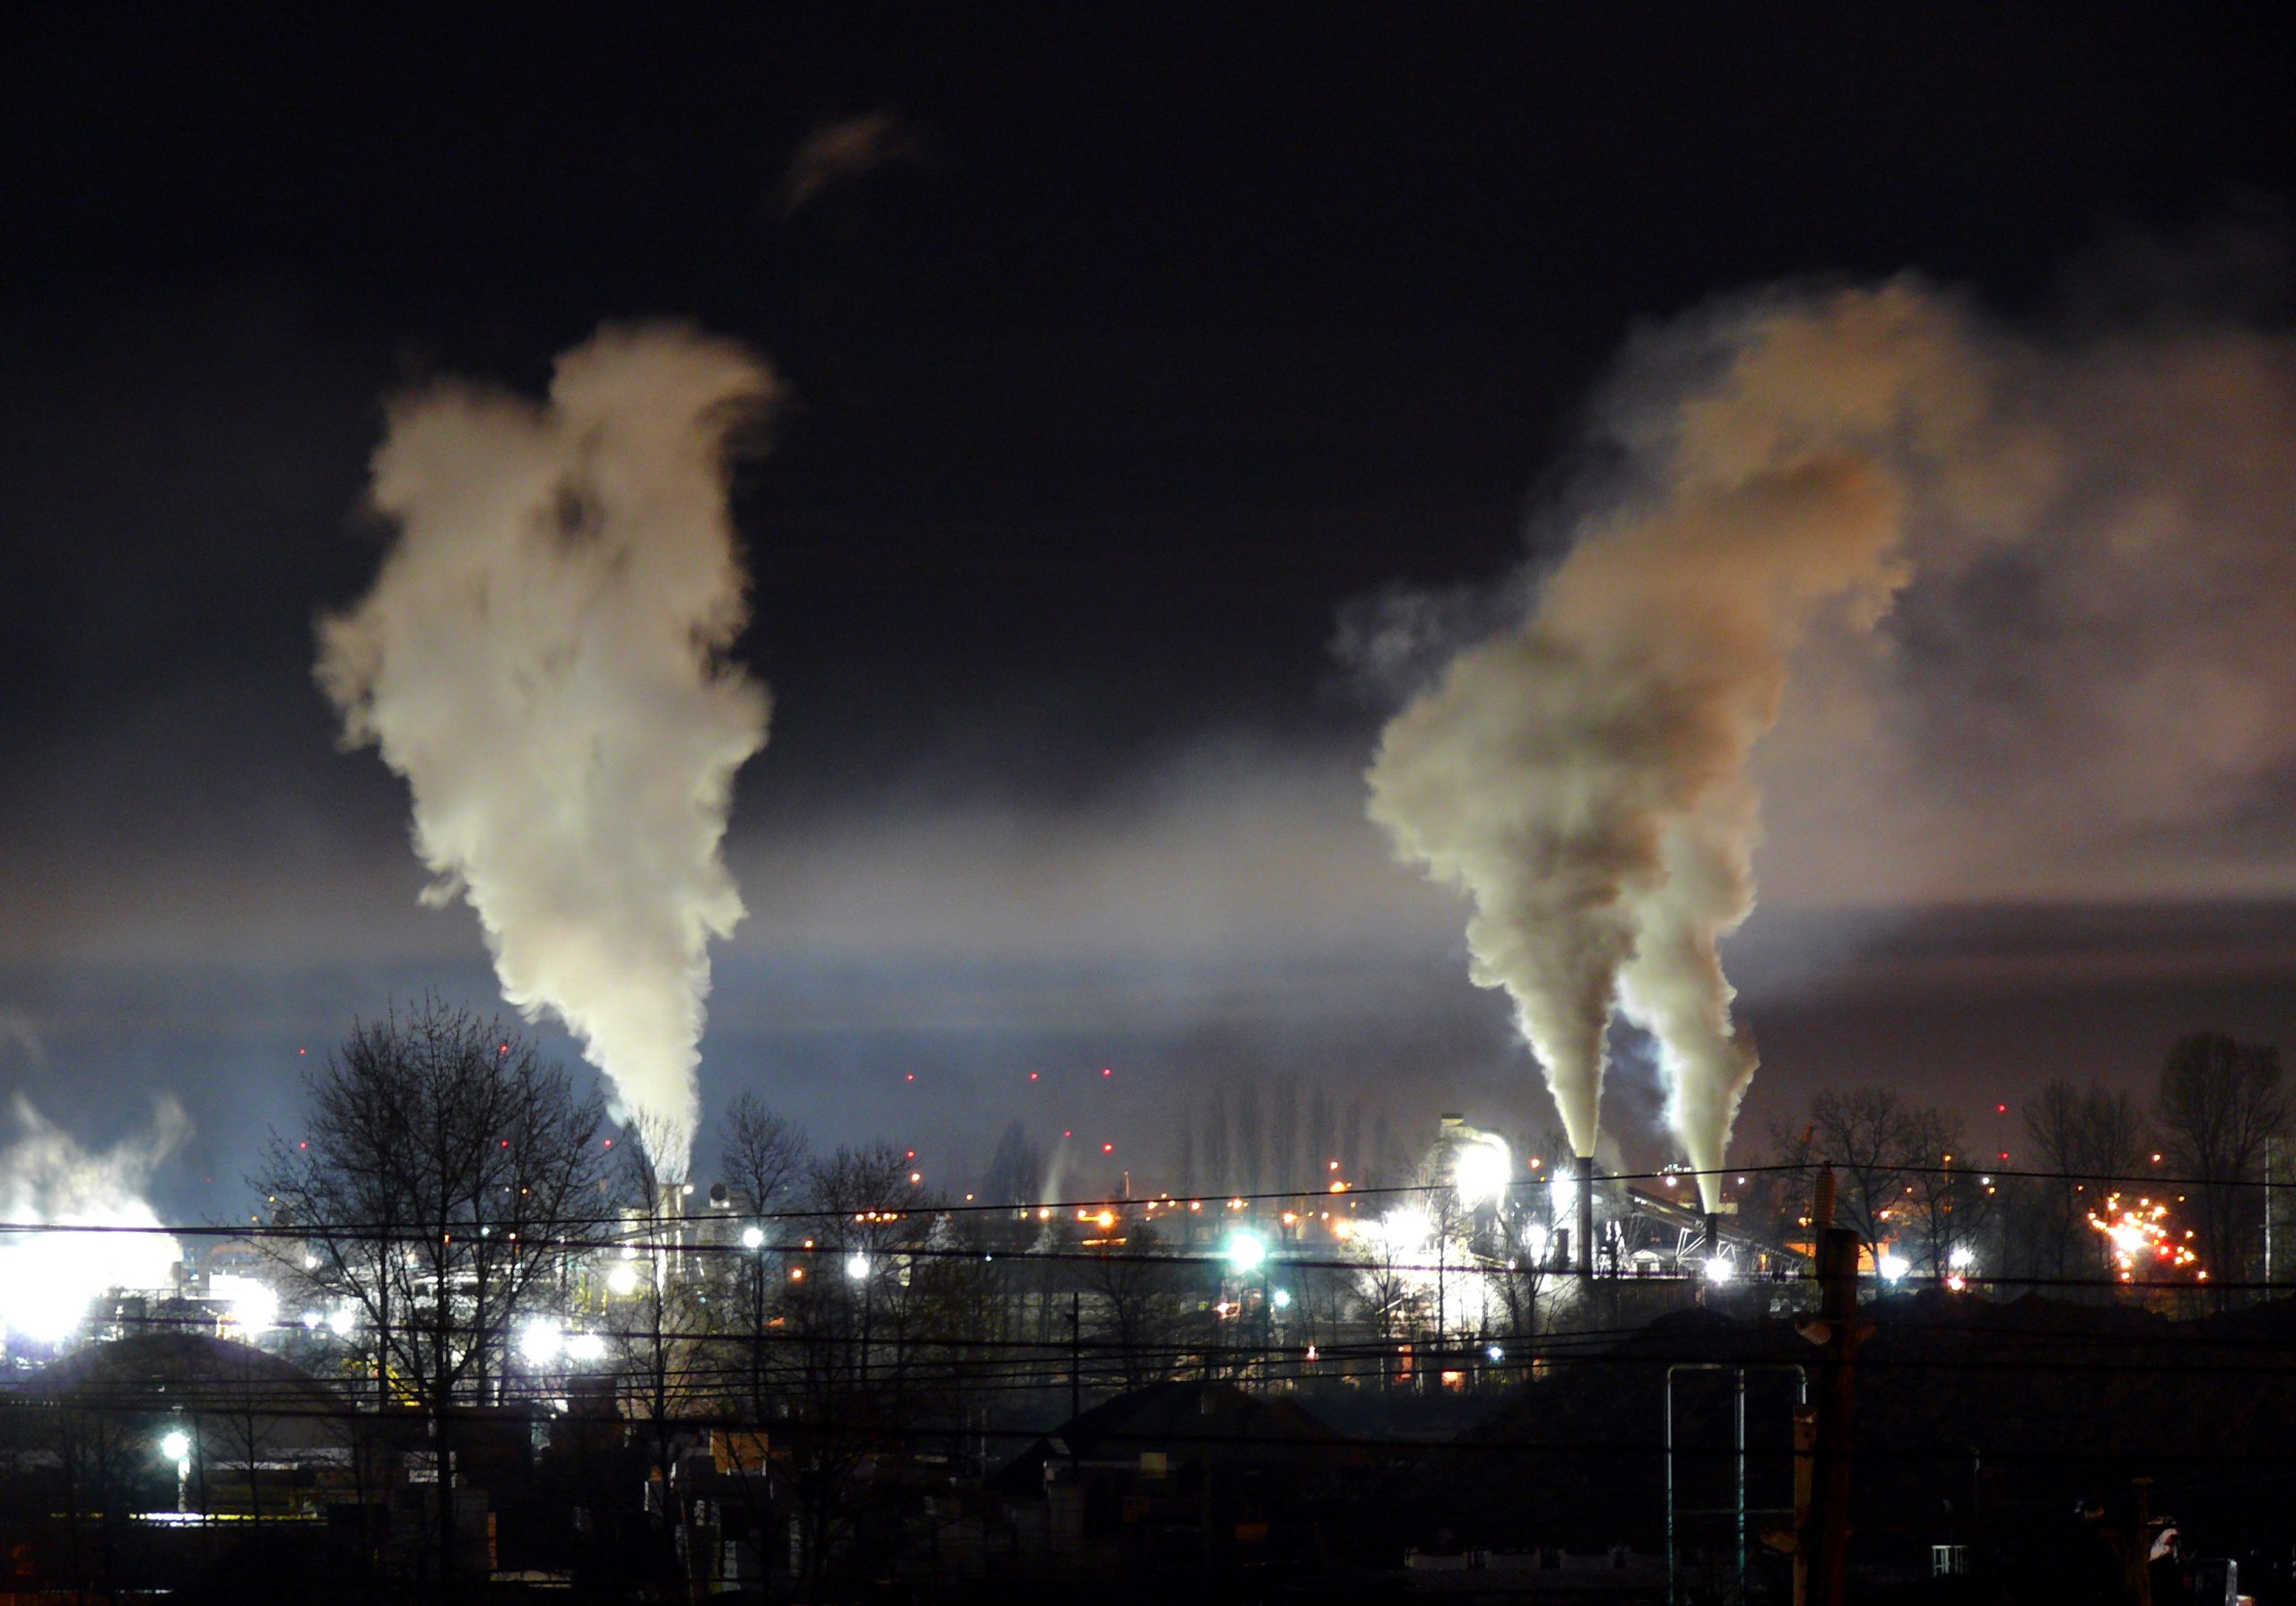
[1369,284,2030,1207]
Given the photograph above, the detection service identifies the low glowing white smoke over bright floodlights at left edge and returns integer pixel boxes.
[0,1094,190,1342]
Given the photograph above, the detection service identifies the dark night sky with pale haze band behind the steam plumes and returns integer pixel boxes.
[0,7,2296,1211]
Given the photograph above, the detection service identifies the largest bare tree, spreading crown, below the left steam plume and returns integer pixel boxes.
[250,995,602,1576]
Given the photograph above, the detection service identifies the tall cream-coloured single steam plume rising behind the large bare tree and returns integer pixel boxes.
[317,326,774,1177]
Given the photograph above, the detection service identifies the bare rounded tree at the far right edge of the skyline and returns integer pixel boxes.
[2153,1032,2289,1285]
